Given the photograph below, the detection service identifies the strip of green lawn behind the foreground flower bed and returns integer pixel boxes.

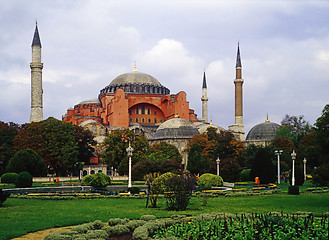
[0,193,329,239]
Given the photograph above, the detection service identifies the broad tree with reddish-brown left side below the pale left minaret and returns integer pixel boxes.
[14,117,94,175]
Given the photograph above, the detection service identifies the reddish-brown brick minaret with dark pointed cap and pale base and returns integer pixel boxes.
[229,43,246,141]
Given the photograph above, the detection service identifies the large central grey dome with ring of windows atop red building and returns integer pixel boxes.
[99,71,170,97]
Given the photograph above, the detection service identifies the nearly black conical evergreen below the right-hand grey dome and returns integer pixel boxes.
[250,147,276,183]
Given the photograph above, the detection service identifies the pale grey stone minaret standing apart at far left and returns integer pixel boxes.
[30,23,43,122]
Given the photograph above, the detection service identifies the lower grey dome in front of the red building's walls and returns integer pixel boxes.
[152,118,199,139]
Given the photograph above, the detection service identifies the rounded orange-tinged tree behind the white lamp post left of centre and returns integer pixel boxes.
[103,129,149,175]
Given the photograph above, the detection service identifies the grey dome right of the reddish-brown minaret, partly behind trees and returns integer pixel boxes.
[246,121,280,141]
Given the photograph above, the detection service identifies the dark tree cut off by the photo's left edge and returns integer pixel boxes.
[0,121,20,175]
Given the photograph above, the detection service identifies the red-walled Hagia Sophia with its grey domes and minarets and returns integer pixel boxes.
[30,26,280,173]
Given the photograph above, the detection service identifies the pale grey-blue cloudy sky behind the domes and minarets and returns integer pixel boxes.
[0,0,329,132]
